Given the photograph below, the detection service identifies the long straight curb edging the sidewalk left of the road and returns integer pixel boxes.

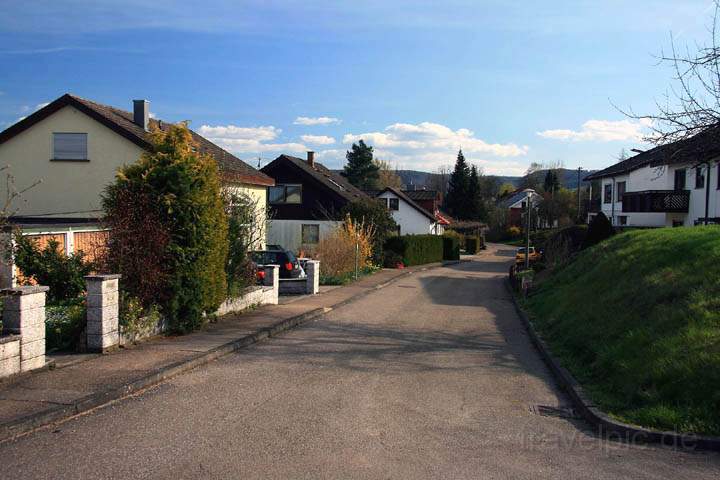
[0,265,442,444]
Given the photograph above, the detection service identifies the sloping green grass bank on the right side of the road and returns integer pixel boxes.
[524,227,720,435]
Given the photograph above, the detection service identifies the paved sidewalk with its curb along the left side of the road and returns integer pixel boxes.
[0,264,440,442]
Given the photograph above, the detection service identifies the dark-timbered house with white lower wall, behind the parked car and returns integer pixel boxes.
[261,152,370,252]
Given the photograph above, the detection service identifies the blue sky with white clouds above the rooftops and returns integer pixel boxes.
[0,0,713,175]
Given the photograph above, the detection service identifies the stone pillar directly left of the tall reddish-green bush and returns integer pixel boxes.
[85,275,120,352]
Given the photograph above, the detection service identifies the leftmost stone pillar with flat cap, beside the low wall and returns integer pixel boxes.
[2,285,50,372]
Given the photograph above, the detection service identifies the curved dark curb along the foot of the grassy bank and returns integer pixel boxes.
[504,280,720,451]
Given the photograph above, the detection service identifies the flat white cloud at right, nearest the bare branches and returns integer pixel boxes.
[537,119,652,142]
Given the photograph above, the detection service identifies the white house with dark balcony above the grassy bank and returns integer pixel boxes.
[585,126,720,227]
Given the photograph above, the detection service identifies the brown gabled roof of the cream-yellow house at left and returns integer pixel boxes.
[0,93,275,186]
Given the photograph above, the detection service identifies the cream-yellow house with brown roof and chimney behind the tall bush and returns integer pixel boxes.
[0,94,274,278]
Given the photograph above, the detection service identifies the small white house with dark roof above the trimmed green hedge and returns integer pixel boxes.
[369,187,447,235]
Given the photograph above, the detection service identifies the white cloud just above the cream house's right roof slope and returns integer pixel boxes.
[198,125,308,154]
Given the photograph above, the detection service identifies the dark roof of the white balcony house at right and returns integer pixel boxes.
[584,125,720,181]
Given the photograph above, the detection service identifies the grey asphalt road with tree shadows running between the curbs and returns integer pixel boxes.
[0,248,720,480]
